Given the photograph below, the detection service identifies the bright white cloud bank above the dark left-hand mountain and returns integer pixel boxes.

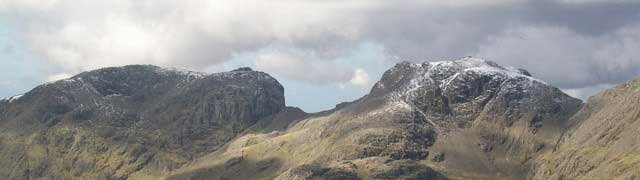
[5,0,376,76]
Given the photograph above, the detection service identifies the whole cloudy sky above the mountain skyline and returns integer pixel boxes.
[0,0,640,112]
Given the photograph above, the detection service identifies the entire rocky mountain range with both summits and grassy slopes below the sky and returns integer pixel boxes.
[0,57,640,180]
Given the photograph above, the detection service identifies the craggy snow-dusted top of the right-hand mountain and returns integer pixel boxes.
[370,57,580,129]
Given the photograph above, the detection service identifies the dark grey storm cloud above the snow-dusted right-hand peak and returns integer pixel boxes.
[350,1,640,89]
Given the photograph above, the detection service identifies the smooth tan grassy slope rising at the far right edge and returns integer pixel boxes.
[532,80,640,180]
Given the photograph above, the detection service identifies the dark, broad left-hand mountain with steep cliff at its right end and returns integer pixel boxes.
[0,65,284,179]
